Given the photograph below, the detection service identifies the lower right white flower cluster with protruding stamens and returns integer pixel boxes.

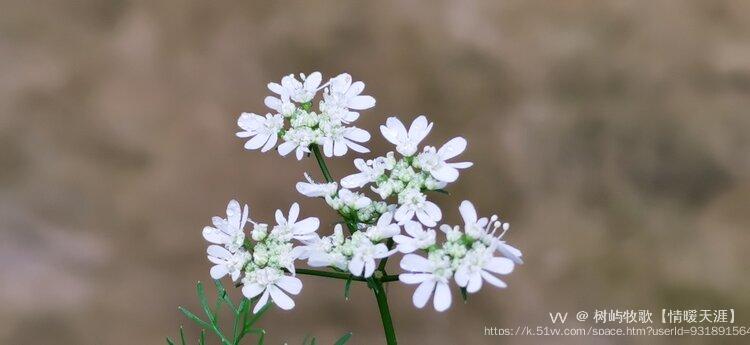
[394,201,521,311]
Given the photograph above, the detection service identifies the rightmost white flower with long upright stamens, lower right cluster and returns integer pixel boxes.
[458,200,523,264]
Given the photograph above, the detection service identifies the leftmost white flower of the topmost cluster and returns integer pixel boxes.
[237,113,284,152]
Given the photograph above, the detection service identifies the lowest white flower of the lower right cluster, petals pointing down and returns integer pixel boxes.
[398,254,453,311]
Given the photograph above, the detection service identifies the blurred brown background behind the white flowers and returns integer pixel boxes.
[0,0,750,344]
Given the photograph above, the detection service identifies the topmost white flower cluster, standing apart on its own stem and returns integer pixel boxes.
[237,72,375,160]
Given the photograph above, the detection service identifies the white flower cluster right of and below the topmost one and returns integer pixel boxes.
[341,116,472,226]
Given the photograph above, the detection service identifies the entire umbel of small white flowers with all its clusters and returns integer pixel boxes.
[203,72,522,312]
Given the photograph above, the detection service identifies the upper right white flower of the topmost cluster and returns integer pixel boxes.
[320,73,375,123]
